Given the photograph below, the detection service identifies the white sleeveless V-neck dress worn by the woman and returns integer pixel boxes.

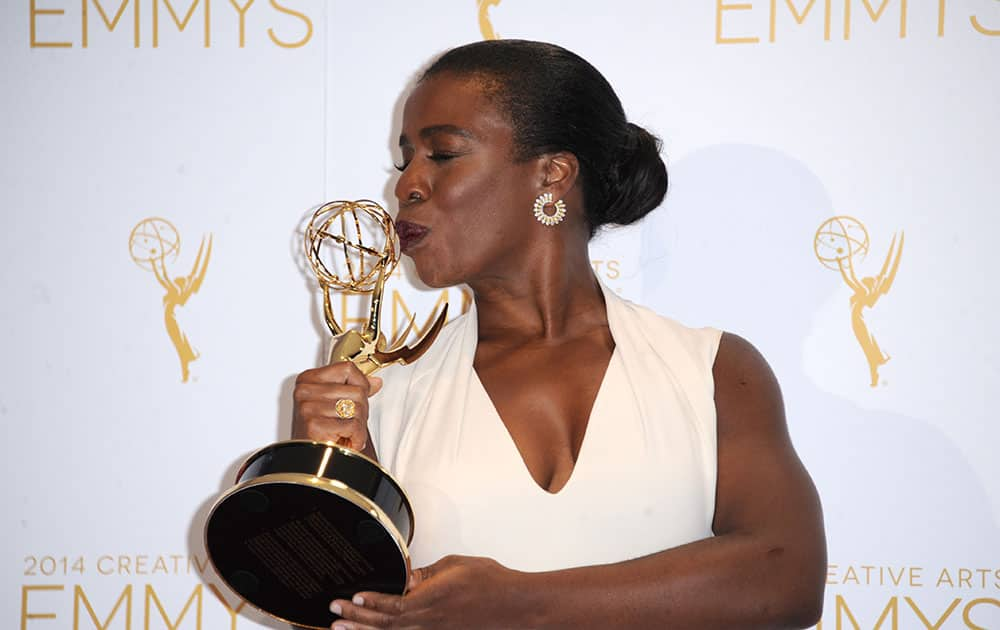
[369,289,721,571]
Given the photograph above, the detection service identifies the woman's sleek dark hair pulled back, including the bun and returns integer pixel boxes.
[420,39,667,235]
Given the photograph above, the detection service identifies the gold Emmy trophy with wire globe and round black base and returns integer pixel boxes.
[205,200,447,628]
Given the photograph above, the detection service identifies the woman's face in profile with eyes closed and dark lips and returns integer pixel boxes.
[395,74,544,287]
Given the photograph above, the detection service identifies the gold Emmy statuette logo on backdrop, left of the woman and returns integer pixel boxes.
[128,217,212,383]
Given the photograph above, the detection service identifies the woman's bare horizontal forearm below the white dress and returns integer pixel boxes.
[515,534,825,630]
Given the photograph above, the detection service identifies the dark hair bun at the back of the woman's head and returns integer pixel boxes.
[593,123,667,225]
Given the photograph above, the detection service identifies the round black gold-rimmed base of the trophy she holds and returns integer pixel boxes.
[205,441,412,628]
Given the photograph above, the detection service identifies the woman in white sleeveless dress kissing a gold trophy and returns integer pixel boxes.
[294,40,825,629]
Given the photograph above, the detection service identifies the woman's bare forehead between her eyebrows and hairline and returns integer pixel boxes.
[402,74,511,142]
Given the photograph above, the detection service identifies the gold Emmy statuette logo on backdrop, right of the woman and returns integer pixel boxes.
[813,216,904,387]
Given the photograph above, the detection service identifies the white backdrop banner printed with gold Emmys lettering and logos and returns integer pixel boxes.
[0,0,1000,630]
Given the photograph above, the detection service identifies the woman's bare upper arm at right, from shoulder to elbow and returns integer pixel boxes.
[712,333,826,579]
